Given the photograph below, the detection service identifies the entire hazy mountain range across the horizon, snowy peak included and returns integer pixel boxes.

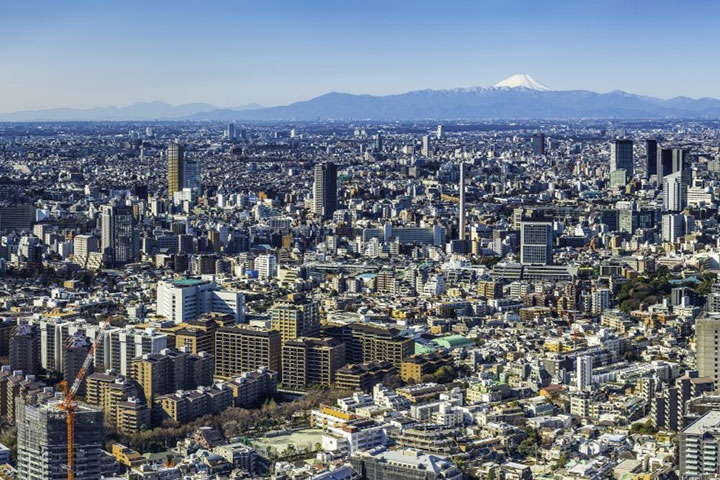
[0,74,720,121]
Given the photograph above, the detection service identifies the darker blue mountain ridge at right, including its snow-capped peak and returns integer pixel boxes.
[208,78,720,121]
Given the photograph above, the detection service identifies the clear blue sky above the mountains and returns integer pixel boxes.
[0,0,720,112]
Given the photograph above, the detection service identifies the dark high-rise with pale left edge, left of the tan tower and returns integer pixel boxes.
[100,205,140,266]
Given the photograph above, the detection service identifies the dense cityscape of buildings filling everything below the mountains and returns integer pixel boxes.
[0,117,720,480]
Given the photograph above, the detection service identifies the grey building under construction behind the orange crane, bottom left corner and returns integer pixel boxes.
[15,398,103,480]
